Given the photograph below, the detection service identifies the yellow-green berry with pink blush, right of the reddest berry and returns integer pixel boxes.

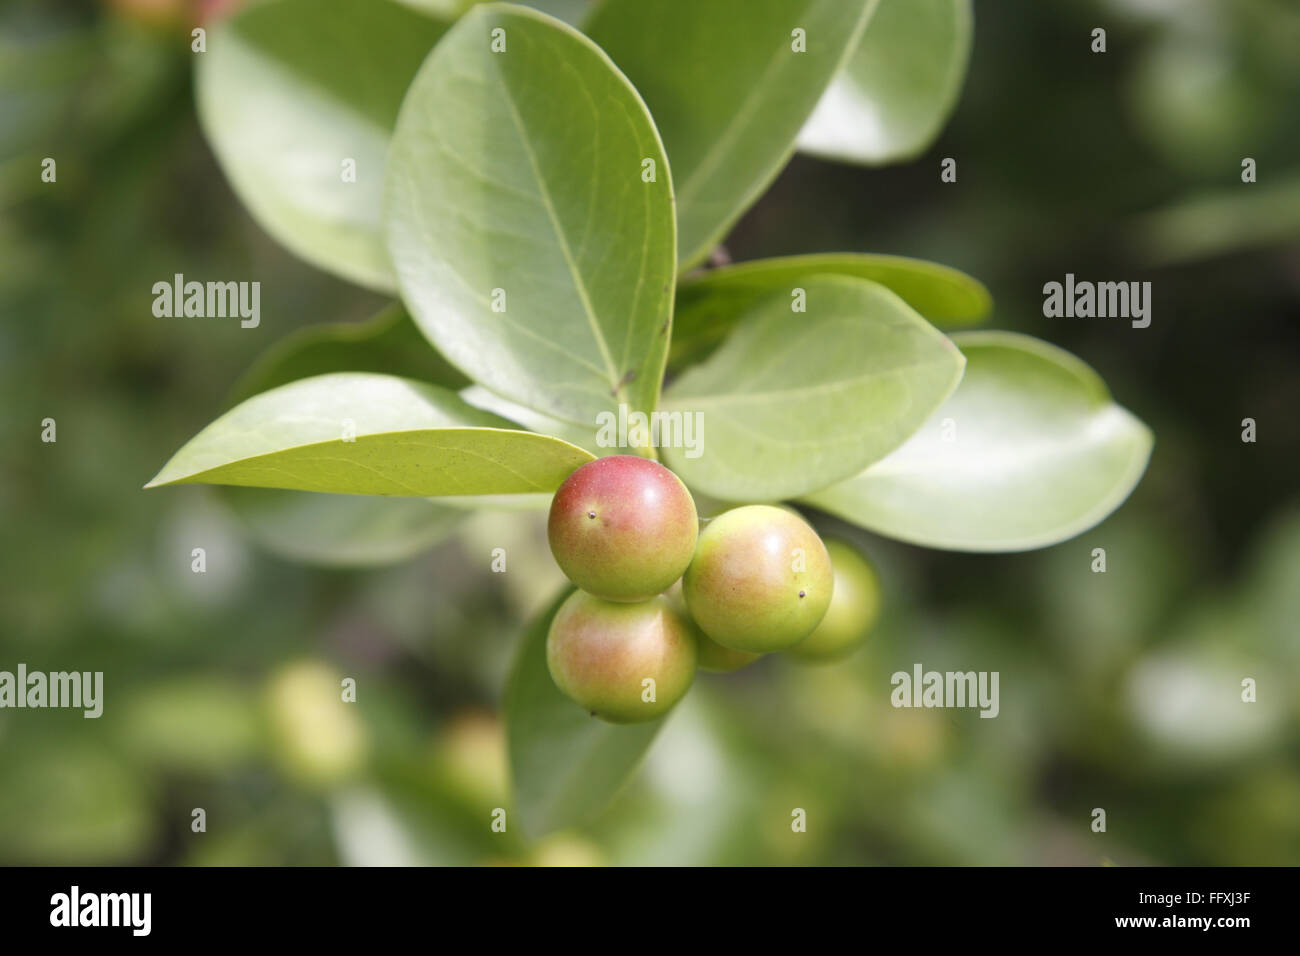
[681,505,833,654]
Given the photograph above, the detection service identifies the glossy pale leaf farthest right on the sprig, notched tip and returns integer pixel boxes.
[805,332,1153,551]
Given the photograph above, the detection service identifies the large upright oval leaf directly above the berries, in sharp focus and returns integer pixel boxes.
[385,4,676,424]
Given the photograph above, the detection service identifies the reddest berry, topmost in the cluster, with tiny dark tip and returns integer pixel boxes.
[546,455,699,601]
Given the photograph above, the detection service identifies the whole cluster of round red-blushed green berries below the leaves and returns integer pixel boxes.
[546,455,880,723]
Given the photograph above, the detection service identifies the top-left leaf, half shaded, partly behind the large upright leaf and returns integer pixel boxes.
[196,0,446,291]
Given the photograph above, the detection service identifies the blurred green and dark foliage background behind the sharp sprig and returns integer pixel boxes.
[0,0,1300,865]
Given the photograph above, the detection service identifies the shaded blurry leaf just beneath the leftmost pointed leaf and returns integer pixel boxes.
[221,486,467,567]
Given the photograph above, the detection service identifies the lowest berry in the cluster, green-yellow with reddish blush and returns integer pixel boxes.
[546,591,696,723]
